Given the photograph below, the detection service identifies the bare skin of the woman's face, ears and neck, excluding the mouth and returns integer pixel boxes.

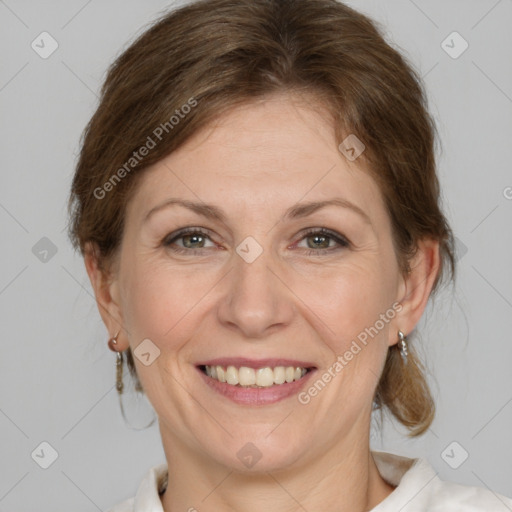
[85,95,439,512]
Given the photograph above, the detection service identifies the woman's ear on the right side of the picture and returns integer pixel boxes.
[389,238,440,345]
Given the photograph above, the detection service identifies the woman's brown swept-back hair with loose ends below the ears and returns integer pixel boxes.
[69,0,455,436]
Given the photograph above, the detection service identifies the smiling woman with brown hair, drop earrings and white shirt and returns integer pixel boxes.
[70,0,512,512]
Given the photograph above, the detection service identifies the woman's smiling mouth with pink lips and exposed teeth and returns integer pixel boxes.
[196,359,316,405]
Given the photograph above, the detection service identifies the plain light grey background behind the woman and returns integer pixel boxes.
[0,0,512,512]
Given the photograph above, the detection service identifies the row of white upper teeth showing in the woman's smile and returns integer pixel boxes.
[205,366,307,388]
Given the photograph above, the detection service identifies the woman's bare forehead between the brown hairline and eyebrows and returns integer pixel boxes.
[128,96,384,226]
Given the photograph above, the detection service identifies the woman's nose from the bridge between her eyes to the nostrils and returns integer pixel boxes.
[219,236,292,338]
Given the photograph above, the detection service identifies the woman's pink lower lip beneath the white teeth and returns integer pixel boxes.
[197,368,315,405]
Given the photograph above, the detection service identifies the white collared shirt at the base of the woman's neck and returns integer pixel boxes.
[108,450,512,512]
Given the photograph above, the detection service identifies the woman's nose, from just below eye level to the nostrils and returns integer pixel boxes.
[218,240,295,339]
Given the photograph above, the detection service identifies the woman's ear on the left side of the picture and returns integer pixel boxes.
[84,242,129,350]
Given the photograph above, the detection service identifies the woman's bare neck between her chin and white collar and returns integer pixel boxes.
[161,422,394,512]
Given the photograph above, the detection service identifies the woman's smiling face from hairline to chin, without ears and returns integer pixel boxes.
[95,96,420,471]
